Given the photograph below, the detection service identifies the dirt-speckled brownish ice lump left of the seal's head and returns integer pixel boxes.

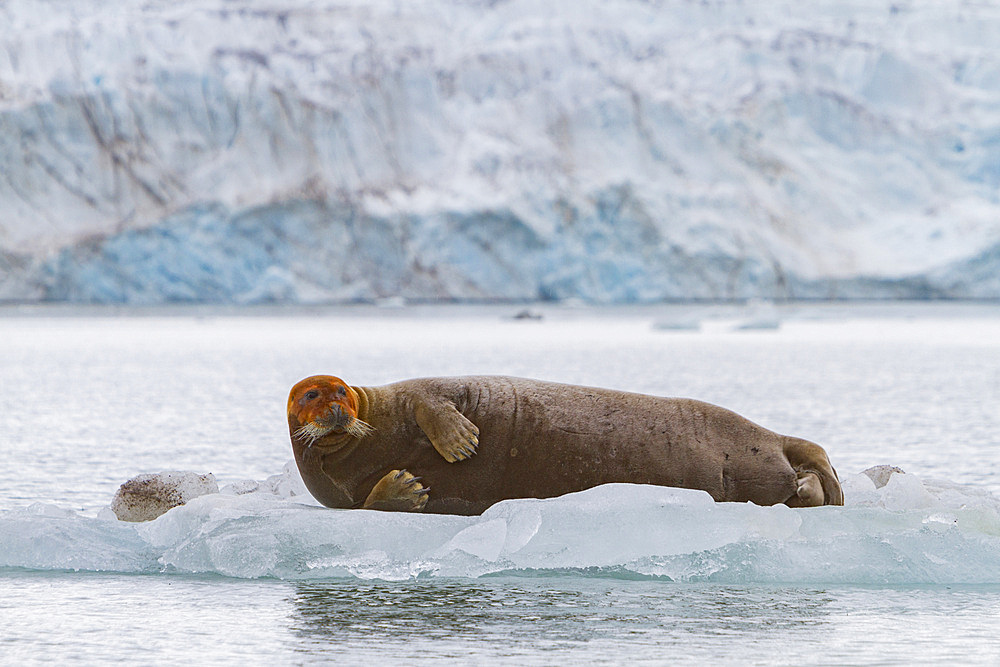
[111,471,219,521]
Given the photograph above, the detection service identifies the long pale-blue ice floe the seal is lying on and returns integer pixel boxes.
[0,473,1000,584]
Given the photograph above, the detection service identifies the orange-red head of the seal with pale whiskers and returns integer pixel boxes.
[288,375,372,447]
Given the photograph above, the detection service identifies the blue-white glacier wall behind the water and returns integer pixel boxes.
[0,0,1000,304]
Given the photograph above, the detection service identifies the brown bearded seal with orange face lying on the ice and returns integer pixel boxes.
[288,375,844,515]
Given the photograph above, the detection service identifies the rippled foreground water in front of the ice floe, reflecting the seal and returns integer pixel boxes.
[7,573,1000,665]
